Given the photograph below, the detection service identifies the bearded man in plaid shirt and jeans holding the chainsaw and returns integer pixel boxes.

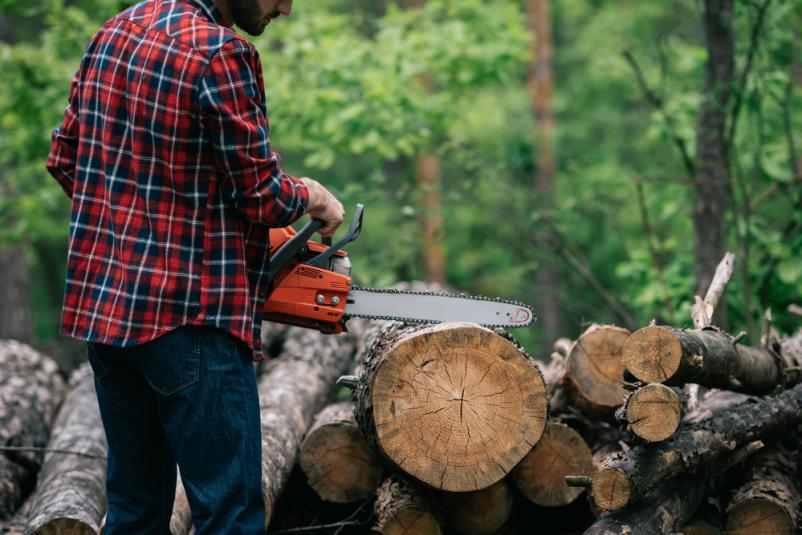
[47,0,344,535]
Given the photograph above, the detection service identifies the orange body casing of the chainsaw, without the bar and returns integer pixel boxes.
[263,227,351,334]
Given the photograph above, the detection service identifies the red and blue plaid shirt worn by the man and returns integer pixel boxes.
[47,0,308,360]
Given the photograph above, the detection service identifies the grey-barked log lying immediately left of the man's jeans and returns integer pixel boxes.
[28,364,108,535]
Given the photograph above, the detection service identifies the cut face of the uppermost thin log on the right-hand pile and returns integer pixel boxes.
[622,325,682,383]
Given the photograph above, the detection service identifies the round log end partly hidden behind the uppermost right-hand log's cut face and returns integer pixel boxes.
[567,325,630,413]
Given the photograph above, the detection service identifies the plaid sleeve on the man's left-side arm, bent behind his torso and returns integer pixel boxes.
[46,71,80,198]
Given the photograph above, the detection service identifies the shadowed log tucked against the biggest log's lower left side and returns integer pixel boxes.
[298,401,382,503]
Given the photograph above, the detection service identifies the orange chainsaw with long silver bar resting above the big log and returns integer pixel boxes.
[263,204,534,334]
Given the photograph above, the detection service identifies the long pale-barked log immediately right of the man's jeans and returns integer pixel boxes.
[259,327,354,524]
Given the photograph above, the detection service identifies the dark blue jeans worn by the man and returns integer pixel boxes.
[87,325,265,535]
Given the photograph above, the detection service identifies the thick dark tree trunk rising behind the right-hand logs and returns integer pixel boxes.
[693,0,735,328]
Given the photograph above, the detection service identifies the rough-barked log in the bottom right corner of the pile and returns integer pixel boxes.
[727,440,800,535]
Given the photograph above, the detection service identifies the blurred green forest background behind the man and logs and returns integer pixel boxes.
[0,0,802,368]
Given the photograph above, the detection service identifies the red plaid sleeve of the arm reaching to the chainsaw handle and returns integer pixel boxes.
[199,39,309,227]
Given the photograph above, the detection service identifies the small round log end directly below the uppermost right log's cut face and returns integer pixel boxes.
[624,383,682,442]
